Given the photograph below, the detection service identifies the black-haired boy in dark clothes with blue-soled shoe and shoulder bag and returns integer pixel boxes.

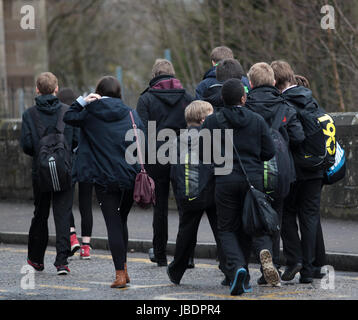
[203,79,279,295]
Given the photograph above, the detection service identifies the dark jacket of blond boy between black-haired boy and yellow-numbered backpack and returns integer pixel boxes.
[245,86,305,148]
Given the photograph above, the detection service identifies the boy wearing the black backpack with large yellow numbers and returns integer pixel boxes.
[271,61,323,283]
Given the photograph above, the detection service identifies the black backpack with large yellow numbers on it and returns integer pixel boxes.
[293,102,337,171]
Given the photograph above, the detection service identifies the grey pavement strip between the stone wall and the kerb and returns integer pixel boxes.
[0,201,358,254]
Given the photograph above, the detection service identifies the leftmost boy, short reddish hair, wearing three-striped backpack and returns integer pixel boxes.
[21,72,78,275]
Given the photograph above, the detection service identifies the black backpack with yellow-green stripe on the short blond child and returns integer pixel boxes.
[170,129,215,211]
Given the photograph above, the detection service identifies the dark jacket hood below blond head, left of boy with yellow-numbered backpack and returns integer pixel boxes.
[245,86,284,121]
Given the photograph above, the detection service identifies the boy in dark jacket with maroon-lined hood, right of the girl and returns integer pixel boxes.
[137,59,193,266]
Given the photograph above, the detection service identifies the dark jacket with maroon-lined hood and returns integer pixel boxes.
[137,75,193,178]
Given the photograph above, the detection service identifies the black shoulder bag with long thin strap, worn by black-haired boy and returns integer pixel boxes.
[231,129,280,236]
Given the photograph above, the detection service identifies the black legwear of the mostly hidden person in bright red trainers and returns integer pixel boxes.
[70,183,93,237]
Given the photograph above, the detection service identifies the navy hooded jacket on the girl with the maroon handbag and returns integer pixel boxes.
[64,98,144,191]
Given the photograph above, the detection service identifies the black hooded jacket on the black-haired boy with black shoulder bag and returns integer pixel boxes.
[202,107,275,183]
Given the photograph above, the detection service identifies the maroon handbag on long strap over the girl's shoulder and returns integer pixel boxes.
[129,111,155,208]
